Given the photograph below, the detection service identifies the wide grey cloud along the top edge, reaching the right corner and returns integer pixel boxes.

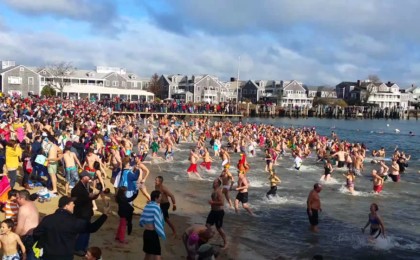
[144,0,420,37]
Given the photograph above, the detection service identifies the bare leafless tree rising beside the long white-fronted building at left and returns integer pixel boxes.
[44,61,76,97]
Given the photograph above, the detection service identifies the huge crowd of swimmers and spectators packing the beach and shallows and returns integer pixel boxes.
[0,94,410,260]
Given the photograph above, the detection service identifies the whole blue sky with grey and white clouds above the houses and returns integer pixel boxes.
[0,0,420,88]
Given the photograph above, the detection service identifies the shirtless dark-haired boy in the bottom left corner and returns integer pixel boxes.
[0,219,26,260]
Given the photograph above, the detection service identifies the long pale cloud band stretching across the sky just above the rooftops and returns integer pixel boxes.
[0,13,420,86]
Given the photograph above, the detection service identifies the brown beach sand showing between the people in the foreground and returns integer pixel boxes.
[27,165,235,260]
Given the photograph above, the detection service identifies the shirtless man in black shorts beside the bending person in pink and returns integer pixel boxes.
[206,178,227,249]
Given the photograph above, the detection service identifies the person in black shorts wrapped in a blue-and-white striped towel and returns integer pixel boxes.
[140,190,166,260]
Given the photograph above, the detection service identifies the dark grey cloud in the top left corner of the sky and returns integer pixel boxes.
[3,0,123,33]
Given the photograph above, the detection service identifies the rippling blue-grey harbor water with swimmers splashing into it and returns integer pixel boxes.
[148,118,420,259]
